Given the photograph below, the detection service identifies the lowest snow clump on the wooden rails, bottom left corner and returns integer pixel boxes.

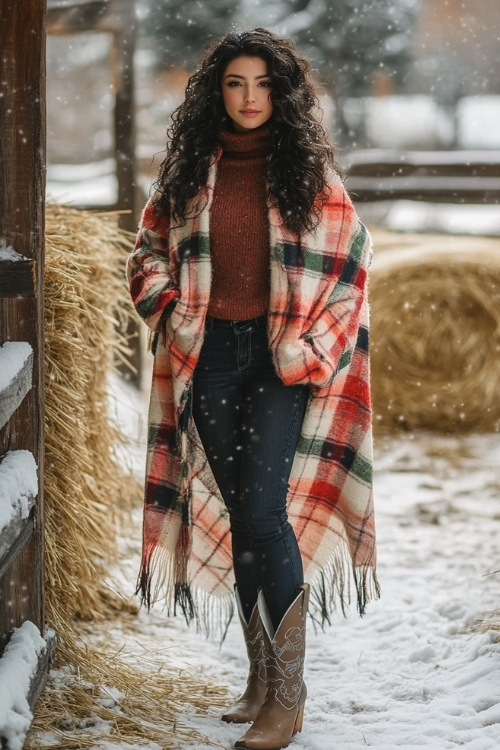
[0,620,47,750]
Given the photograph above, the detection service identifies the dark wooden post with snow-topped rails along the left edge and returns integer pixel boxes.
[0,0,55,748]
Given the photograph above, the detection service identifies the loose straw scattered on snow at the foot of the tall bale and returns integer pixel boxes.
[28,648,226,750]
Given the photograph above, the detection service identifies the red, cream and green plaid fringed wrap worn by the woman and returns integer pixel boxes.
[127,160,378,629]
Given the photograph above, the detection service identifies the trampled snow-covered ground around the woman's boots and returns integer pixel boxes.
[78,382,500,750]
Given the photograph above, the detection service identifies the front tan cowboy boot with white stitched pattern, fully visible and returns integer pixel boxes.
[235,583,309,750]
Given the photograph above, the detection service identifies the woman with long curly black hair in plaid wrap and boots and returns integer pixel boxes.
[128,29,378,750]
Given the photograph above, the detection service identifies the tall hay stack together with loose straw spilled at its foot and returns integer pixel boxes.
[27,205,226,750]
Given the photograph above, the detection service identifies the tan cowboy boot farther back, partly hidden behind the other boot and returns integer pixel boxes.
[222,588,267,724]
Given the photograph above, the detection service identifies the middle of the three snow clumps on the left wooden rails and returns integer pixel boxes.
[0,450,38,540]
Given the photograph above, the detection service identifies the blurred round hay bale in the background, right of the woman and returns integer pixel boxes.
[370,230,500,433]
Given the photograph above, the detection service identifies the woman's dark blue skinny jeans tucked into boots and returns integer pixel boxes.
[193,317,308,627]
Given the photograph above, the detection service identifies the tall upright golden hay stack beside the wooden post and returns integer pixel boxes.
[45,204,138,635]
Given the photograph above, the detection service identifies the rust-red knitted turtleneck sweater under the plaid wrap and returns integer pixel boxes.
[208,128,270,320]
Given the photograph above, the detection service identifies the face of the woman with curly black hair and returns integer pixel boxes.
[222,55,273,133]
